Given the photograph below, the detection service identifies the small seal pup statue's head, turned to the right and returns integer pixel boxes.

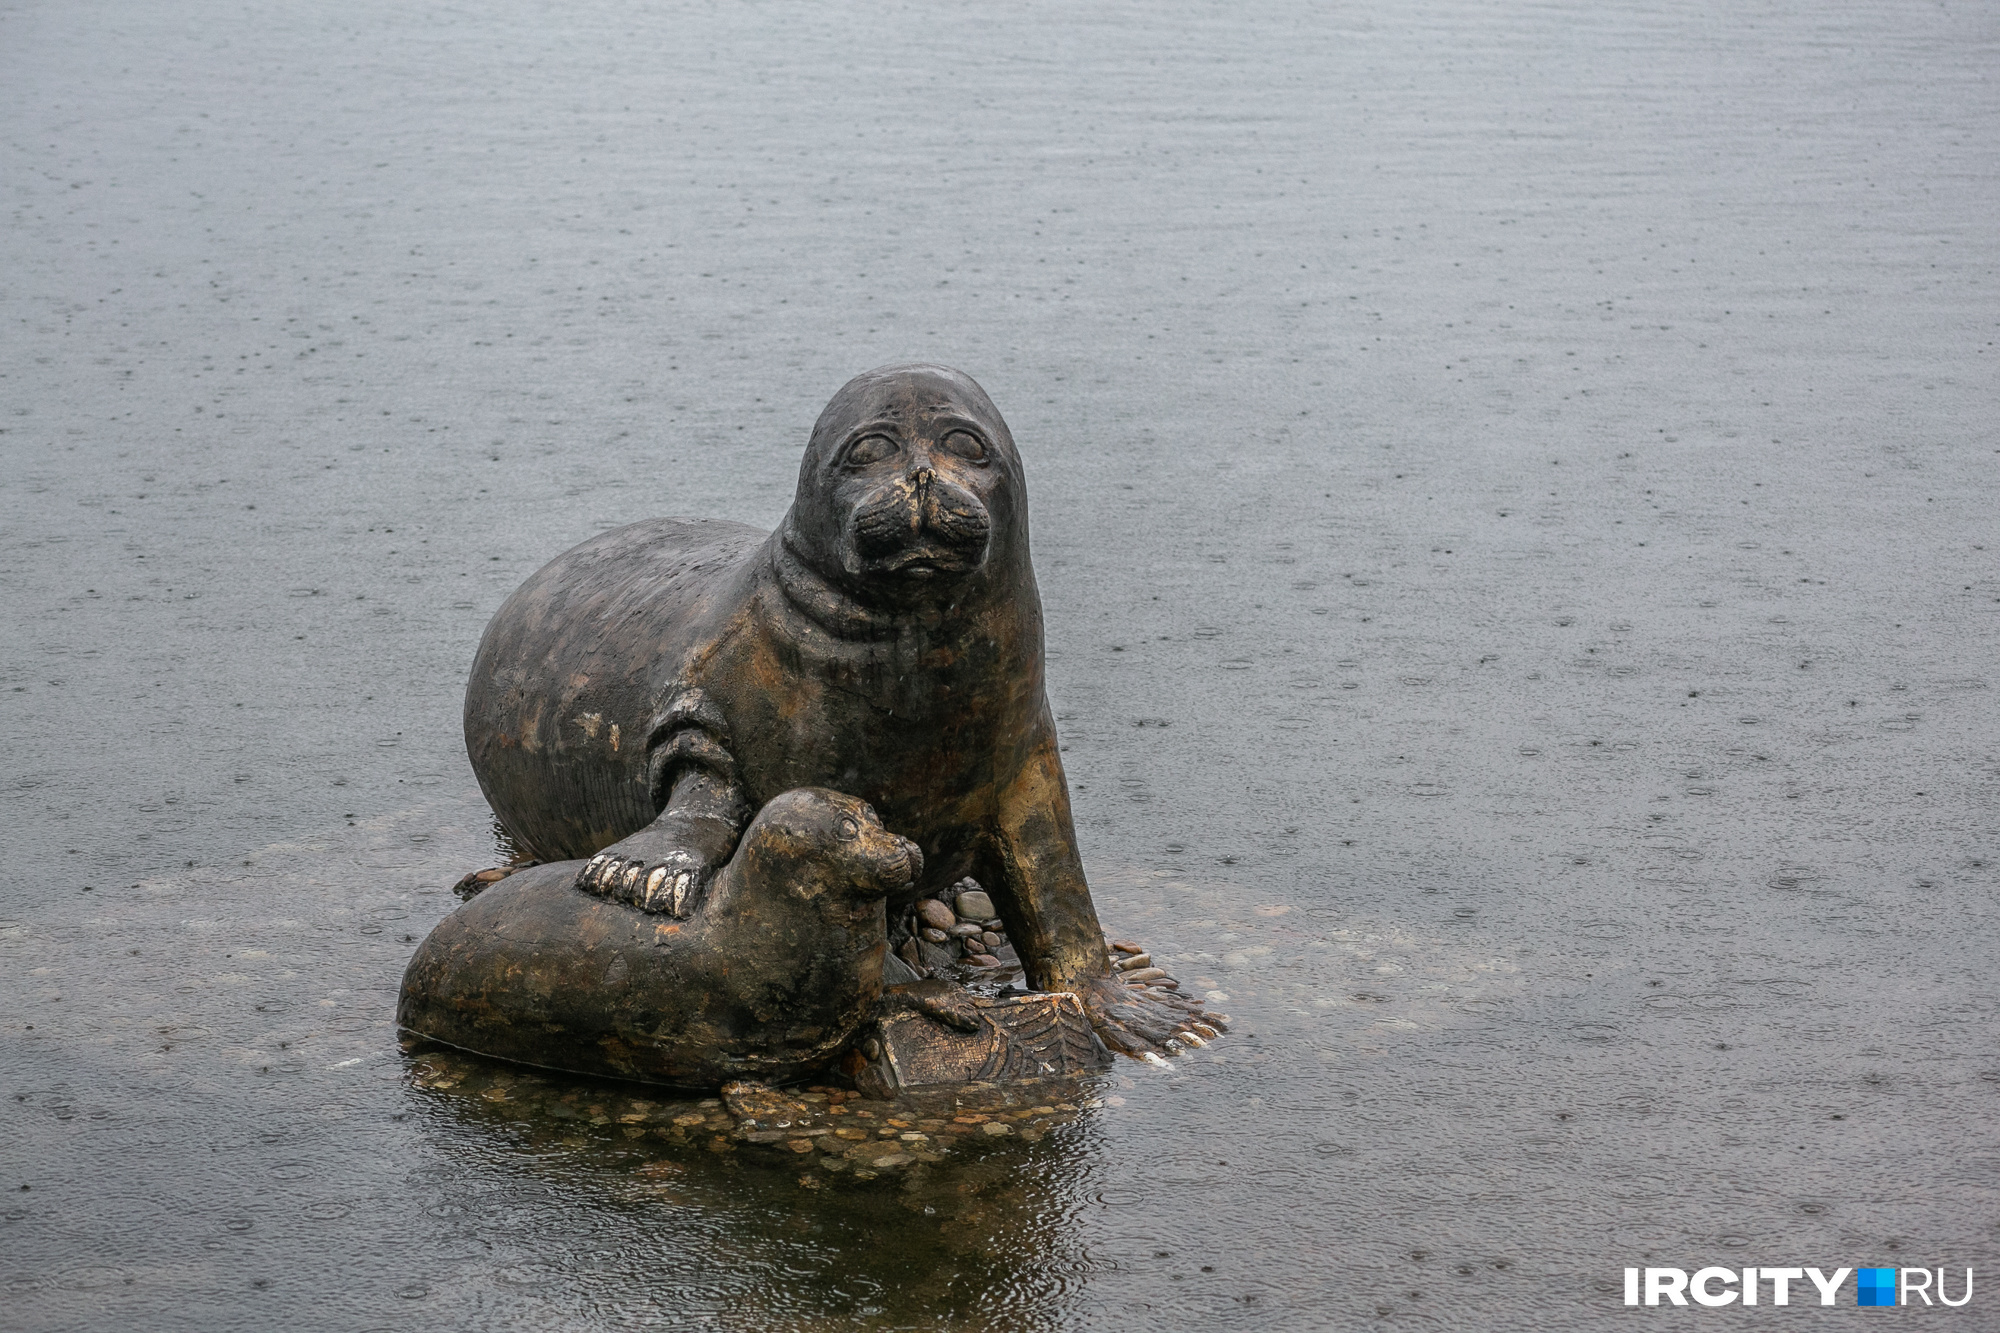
[742,787,924,905]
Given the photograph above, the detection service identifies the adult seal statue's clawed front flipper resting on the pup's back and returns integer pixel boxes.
[576,691,750,917]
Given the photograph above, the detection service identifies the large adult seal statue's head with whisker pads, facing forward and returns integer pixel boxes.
[784,364,1028,606]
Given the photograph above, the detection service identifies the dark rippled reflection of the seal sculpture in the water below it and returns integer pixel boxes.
[408,1043,1102,1333]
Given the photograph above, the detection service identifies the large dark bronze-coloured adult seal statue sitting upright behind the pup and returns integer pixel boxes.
[466,364,1216,1055]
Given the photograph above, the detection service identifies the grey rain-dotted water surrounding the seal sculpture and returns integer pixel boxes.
[0,0,2000,1329]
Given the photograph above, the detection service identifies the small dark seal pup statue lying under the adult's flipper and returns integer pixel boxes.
[396,789,924,1089]
